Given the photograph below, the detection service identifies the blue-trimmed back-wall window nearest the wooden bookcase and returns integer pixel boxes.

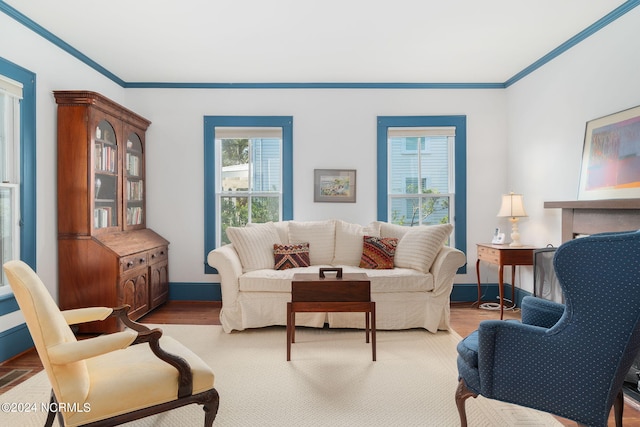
[205,116,293,272]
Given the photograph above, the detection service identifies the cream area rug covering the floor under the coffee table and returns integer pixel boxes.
[0,325,561,427]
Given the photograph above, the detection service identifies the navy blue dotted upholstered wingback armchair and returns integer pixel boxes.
[456,231,640,426]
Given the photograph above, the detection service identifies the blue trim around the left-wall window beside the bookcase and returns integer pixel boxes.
[0,57,36,310]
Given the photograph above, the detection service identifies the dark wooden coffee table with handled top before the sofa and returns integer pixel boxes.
[287,268,376,361]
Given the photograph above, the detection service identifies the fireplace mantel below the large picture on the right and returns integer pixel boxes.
[544,199,640,242]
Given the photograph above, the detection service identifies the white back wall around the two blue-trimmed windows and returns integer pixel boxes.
[126,89,506,283]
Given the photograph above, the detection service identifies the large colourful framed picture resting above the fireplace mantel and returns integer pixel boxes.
[578,106,640,200]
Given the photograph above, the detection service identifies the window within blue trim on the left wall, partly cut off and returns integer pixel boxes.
[0,76,22,286]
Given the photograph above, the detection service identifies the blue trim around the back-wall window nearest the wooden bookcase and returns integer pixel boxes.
[204,116,293,274]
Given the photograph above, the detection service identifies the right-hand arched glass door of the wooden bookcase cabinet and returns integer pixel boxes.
[124,133,145,228]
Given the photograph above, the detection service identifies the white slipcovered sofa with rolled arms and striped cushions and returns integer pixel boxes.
[207,220,466,333]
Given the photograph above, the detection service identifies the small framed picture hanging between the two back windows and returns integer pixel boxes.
[313,169,356,203]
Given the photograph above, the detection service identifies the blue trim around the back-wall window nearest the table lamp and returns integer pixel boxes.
[377,116,467,273]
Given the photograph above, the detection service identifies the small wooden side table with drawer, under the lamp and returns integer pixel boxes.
[476,243,537,320]
